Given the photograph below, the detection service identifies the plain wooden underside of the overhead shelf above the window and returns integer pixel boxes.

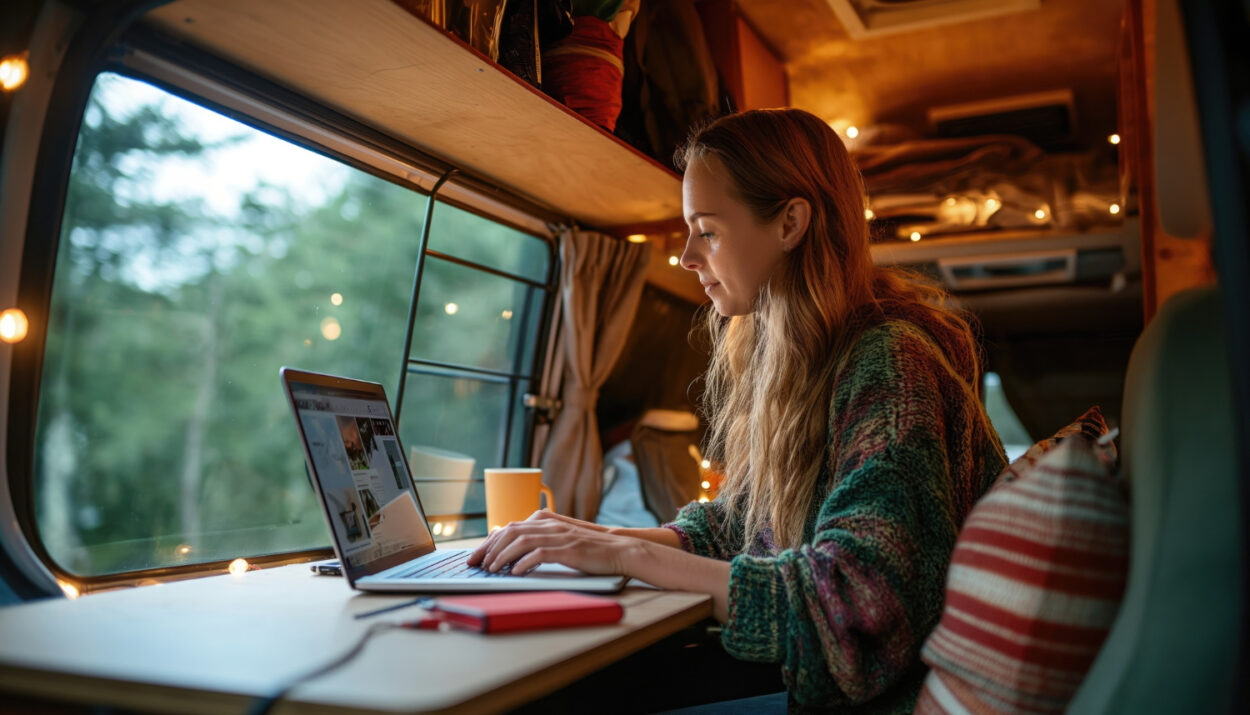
[148,0,681,229]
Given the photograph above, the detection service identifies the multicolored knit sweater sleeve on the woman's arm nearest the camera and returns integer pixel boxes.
[723,326,960,706]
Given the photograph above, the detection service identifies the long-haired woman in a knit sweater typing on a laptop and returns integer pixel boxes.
[470,110,1006,713]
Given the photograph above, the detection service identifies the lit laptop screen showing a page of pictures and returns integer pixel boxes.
[283,370,434,581]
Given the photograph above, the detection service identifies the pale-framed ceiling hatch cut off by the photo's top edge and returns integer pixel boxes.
[829,0,1041,40]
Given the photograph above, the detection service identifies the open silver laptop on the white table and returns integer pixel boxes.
[279,368,626,593]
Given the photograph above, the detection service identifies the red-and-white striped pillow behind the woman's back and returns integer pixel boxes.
[916,434,1129,713]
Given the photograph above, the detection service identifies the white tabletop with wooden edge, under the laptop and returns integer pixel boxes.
[0,547,711,715]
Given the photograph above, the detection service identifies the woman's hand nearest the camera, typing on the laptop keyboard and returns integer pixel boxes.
[469,511,646,575]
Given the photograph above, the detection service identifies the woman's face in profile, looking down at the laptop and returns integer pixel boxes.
[681,156,785,316]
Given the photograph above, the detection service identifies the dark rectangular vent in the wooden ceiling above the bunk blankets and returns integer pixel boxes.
[929,89,1076,146]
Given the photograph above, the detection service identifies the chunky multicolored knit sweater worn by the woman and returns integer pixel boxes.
[666,316,1006,713]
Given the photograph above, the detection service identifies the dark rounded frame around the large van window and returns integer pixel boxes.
[5,23,571,593]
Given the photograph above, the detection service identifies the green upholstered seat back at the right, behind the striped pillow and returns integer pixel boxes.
[1069,289,1244,714]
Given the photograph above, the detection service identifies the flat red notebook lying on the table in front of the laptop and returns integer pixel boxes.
[426,591,625,633]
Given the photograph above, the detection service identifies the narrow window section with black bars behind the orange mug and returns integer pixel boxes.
[399,203,551,538]
